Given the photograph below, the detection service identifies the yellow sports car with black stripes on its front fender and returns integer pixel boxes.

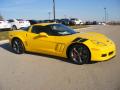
[9,23,116,64]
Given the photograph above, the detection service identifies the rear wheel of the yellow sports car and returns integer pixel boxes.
[12,39,25,54]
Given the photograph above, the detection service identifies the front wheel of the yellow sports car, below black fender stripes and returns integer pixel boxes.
[68,44,91,65]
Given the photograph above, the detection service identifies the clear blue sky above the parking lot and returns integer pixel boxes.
[0,0,120,21]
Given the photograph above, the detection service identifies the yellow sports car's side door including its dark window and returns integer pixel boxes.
[27,25,56,54]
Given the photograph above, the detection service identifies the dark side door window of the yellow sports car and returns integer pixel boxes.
[31,26,50,34]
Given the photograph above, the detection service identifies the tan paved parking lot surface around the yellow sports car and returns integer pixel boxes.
[0,25,120,90]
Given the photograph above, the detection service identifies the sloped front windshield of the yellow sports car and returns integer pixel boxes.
[52,24,76,36]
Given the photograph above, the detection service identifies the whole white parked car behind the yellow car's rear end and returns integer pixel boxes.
[8,19,30,30]
